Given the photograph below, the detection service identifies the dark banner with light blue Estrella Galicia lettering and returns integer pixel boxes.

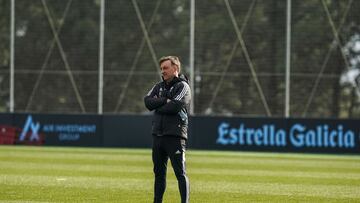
[192,117,360,153]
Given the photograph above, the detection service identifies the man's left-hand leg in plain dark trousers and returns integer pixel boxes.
[152,136,168,203]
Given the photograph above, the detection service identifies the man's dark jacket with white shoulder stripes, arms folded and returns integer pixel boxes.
[144,75,191,139]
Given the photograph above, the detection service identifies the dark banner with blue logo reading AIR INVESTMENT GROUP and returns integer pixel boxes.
[13,114,102,146]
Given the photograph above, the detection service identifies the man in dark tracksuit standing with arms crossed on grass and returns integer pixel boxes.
[144,56,191,203]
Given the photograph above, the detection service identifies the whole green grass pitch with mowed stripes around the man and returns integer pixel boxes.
[0,146,360,203]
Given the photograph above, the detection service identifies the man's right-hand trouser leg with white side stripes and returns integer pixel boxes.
[170,138,190,203]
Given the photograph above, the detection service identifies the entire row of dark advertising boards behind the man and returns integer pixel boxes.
[0,114,360,154]
